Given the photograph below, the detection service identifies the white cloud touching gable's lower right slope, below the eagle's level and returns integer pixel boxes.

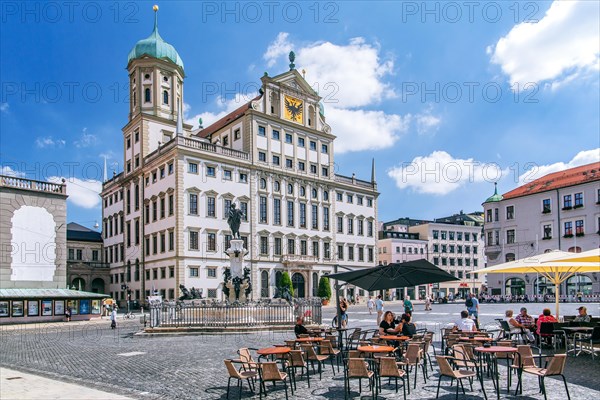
[327,108,410,153]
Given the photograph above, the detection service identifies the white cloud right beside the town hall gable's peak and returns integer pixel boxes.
[296,38,395,108]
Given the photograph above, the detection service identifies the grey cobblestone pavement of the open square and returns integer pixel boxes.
[0,304,600,399]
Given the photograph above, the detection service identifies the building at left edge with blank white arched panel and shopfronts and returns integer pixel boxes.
[0,175,105,324]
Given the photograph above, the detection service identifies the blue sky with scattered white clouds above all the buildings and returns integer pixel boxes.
[0,1,600,226]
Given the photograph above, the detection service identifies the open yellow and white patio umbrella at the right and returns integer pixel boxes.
[471,249,600,318]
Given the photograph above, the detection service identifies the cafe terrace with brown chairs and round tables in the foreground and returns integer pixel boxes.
[223,322,600,399]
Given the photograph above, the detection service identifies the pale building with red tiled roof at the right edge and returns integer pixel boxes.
[483,163,600,296]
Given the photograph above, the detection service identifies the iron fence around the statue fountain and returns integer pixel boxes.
[150,298,323,328]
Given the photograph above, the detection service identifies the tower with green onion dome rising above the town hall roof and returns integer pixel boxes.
[123,5,185,167]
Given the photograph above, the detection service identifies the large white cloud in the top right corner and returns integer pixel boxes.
[487,1,600,89]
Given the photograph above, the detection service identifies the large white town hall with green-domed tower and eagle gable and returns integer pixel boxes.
[101,12,378,302]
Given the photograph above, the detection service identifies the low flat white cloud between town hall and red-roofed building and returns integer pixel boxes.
[387,151,507,195]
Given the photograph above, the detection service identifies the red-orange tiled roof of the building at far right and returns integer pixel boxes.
[502,162,600,200]
